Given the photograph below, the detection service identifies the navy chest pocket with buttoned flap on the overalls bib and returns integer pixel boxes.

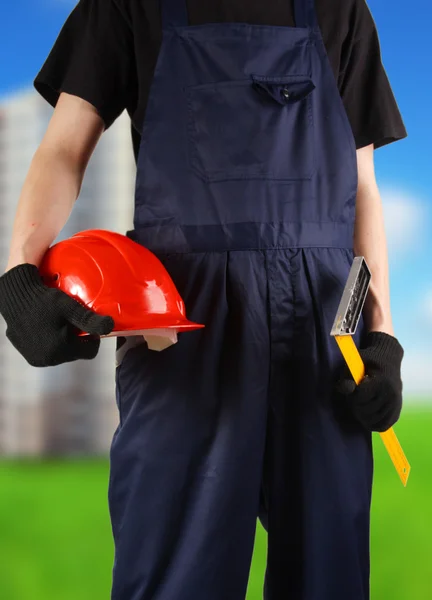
[186,75,315,182]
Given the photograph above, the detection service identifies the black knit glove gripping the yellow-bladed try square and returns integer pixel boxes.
[336,331,404,431]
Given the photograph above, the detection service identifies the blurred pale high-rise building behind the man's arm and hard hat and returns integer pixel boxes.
[0,90,135,456]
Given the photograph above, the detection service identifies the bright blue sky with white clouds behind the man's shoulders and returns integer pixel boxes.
[0,0,432,399]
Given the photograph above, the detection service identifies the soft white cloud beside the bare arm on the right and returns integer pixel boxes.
[381,189,428,258]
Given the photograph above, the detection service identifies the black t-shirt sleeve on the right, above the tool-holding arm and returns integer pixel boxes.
[338,0,407,148]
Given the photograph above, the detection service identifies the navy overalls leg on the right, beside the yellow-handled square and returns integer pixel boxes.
[264,249,372,600]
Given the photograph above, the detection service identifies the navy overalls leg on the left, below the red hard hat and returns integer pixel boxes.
[109,252,269,600]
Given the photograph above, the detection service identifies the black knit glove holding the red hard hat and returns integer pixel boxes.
[0,264,114,367]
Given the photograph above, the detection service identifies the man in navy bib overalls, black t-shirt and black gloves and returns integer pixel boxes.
[0,0,406,600]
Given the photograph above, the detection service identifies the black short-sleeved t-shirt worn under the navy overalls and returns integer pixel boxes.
[35,0,406,162]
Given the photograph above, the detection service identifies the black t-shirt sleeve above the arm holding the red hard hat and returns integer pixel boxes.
[34,0,137,128]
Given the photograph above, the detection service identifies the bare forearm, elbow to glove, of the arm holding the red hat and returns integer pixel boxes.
[6,148,82,270]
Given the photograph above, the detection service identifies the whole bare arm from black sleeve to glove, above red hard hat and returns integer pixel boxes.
[6,94,104,270]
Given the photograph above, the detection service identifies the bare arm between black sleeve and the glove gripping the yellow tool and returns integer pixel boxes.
[354,149,394,335]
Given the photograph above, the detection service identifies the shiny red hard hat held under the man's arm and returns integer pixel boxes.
[39,230,204,352]
